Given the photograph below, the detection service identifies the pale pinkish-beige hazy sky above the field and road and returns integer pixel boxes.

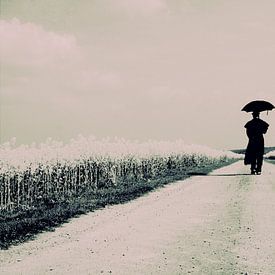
[0,0,275,149]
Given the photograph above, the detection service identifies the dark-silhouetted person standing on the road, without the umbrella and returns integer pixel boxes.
[244,112,269,175]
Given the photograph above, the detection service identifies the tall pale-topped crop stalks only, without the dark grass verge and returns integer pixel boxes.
[0,137,239,212]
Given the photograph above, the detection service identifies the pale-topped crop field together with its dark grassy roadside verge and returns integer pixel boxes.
[0,136,240,248]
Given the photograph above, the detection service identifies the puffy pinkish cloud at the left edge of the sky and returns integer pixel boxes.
[0,18,80,67]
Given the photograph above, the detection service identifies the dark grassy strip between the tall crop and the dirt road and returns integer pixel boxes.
[0,160,237,249]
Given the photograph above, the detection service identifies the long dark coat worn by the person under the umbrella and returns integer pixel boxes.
[244,118,269,164]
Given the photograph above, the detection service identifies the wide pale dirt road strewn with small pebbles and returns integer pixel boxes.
[0,162,275,275]
